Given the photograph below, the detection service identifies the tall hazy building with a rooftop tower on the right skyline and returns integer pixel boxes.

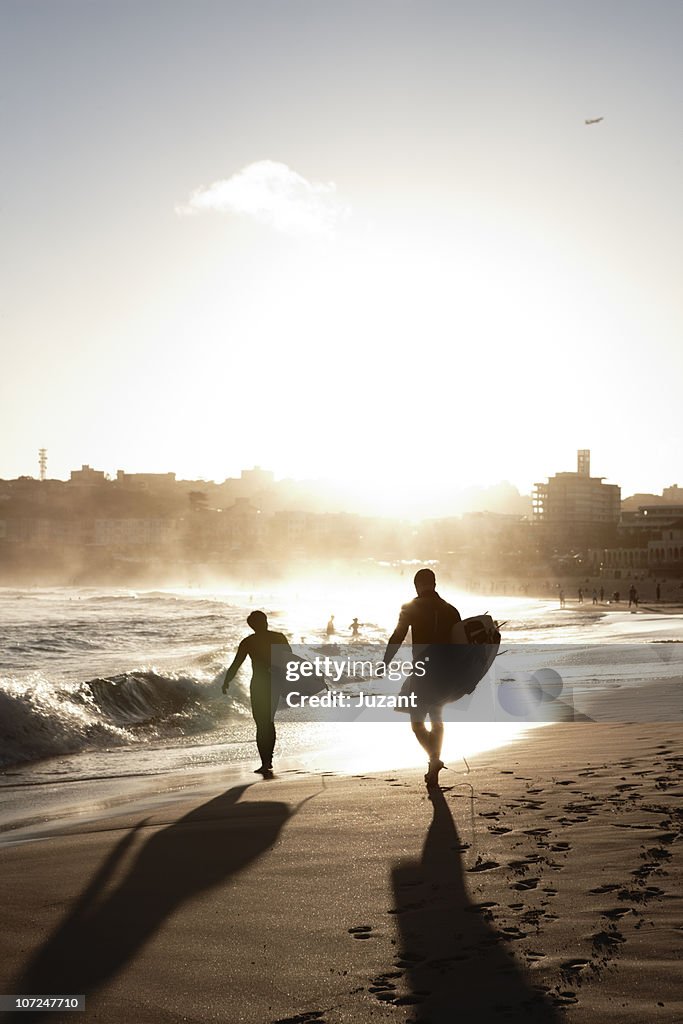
[531,449,622,526]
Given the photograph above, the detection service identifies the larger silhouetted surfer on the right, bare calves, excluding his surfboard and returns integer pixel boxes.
[384,569,461,787]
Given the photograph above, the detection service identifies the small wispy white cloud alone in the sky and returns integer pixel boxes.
[176,160,349,234]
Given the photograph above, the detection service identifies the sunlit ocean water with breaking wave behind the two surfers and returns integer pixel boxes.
[0,578,681,787]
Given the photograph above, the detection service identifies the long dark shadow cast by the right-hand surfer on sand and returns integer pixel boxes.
[387,790,560,1024]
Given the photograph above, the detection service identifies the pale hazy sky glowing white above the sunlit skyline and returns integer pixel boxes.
[0,0,683,513]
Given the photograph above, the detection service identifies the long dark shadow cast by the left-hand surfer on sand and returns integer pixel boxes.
[13,785,291,1022]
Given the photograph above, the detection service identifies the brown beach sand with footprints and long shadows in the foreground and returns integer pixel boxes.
[0,723,683,1024]
